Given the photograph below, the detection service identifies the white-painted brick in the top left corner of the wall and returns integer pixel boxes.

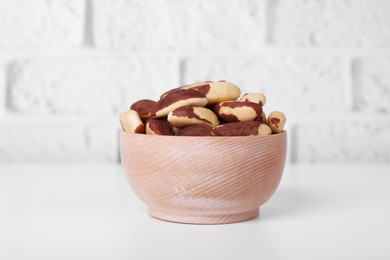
[0,0,85,49]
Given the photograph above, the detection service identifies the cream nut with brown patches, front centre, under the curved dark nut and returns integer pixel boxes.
[168,106,219,128]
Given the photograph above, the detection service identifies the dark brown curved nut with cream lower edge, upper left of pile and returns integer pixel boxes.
[153,89,207,118]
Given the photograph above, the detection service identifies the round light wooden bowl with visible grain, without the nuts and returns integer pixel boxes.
[120,131,287,224]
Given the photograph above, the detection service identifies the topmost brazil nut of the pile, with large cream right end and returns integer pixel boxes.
[162,80,241,105]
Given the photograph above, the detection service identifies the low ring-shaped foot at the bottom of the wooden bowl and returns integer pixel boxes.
[148,208,259,224]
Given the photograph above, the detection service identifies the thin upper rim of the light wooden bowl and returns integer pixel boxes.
[120,129,287,140]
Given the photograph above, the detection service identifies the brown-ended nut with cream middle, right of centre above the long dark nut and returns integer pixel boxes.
[214,101,263,123]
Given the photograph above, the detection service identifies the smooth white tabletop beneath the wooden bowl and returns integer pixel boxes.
[0,165,390,260]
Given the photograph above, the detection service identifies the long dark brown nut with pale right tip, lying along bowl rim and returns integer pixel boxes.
[214,121,272,136]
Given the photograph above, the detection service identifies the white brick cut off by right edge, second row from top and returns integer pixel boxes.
[353,57,390,113]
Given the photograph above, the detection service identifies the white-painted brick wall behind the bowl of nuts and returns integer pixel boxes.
[0,0,390,164]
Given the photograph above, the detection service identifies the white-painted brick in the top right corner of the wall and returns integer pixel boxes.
[269,0,390,48]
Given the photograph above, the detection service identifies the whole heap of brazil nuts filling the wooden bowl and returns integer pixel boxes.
[120,80,286,136]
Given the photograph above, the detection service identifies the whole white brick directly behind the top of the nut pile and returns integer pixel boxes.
[183,56,347,116]
